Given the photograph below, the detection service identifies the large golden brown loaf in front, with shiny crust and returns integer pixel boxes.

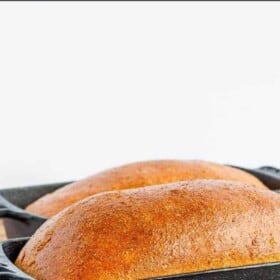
[16,180,280,280]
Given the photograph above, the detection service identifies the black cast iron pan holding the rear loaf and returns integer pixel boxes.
[0,166,280,238]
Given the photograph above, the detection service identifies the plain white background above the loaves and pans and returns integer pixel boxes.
[0,2,280,187]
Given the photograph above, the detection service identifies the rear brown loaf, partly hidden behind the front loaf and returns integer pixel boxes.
[27,160,264,217]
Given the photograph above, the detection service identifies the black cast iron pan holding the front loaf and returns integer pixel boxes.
[0,238,280,280]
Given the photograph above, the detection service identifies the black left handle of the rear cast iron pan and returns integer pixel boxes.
[0,195,34,221]
